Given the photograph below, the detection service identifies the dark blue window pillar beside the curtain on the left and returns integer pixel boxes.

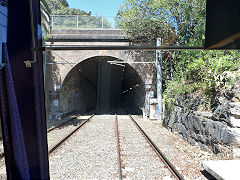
[4,0,49,179]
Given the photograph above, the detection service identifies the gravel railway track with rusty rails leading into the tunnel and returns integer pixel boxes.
[0,109,184,180]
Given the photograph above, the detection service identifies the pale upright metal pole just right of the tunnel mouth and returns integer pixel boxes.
[156,38,163,121]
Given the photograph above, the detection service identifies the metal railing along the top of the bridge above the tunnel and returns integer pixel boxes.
[51,15,121,29]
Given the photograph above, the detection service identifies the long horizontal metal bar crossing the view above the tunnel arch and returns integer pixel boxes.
[41,46,204,51]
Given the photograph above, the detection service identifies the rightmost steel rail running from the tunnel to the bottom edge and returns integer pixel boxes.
[129,114,184,180]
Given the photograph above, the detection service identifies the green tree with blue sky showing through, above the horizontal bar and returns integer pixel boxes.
[118,0,206,45]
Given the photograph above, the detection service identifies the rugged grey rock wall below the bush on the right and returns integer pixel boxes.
[163,96,240,156]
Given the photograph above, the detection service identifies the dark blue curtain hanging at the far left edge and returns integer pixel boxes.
[0,43,30,179]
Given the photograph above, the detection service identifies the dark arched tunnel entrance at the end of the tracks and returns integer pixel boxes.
[60,56,145,114]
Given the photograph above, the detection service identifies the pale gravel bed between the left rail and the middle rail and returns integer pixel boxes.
[49,115,118,179]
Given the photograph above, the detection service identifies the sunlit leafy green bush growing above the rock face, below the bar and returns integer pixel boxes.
[164,51,240,109]
